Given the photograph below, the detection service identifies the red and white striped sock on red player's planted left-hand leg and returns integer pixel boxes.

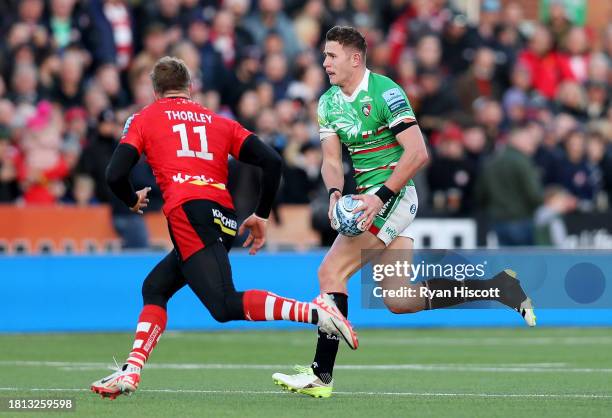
[126,305,168,368]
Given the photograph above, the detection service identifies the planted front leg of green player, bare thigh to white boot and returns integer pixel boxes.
[272,233,384,397]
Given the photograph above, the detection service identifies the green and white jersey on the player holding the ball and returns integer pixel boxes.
[318,70,415,193]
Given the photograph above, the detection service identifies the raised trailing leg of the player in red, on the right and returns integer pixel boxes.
[177,242,358,349]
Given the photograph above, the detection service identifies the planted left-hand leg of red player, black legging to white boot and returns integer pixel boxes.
[91,251,185,399]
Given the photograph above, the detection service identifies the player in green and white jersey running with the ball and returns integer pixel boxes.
[272,26,535,397]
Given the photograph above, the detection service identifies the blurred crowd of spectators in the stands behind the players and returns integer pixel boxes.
[0,0,612,247]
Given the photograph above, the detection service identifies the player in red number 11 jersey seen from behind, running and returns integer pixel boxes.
[91,57,358,399]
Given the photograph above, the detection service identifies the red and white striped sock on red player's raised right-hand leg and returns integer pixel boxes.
[242,290,318,324]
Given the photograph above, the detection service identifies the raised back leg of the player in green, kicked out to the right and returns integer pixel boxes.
[377,236,536,327]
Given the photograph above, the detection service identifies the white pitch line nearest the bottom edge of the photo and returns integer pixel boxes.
[0,387,612,399]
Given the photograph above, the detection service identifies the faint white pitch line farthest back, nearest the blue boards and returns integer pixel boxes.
[164,331,612,346]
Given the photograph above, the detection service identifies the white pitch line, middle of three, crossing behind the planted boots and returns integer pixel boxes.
[0,360,612,373]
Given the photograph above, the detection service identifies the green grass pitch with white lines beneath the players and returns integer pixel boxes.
[0,328,612,418]
